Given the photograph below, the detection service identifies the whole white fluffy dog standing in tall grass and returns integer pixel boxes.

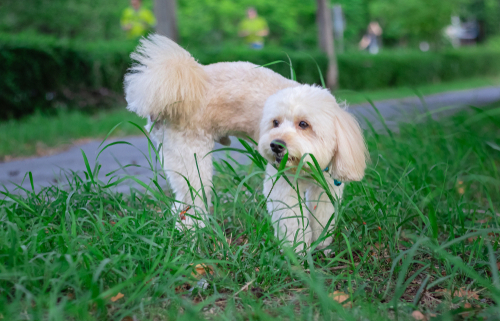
[125,35,367,249]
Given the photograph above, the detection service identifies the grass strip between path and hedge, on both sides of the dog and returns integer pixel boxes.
[0,74,500,161]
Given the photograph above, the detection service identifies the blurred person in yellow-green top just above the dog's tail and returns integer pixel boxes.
[120,0,156,39]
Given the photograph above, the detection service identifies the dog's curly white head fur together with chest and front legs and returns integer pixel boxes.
[259,85,368,246]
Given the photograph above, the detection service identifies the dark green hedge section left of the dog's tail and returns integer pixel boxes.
[0,35,135,118]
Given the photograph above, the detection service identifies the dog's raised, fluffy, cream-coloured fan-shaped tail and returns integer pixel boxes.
[125,35,208,122]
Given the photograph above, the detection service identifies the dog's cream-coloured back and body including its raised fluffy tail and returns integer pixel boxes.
[125,35,299,139]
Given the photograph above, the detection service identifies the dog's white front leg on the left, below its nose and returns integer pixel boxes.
[264,164,312,251]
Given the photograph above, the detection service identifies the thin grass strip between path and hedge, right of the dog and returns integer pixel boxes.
[335,77,500,104]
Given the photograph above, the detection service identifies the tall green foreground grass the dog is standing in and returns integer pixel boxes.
[0,100,500,320]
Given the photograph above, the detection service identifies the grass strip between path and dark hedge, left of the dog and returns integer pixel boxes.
[0,107,145,161]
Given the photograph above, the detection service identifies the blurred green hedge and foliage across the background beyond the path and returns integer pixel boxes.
[0,0,500,119]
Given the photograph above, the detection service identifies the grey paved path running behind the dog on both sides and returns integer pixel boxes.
[0,87,500,192]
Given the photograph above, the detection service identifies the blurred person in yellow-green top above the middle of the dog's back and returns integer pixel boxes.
[238,8,269,50]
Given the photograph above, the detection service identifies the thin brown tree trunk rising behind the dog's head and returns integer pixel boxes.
[316,0,339,90]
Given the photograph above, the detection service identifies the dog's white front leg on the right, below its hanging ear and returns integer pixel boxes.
[306,175,344,249]
